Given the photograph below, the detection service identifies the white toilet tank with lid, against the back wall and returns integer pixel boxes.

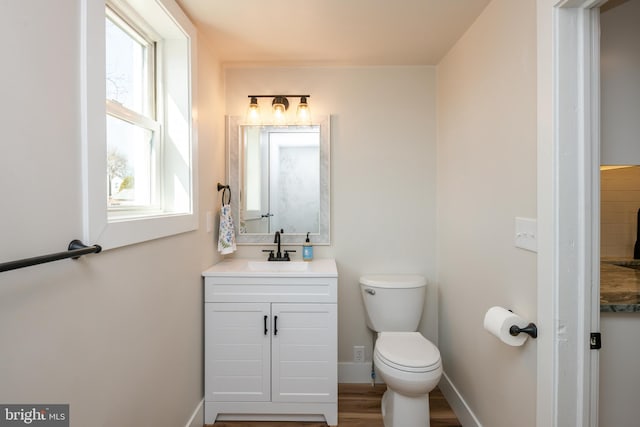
[360,274,427,332]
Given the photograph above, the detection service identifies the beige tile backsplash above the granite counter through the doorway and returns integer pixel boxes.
[600,166,640,258]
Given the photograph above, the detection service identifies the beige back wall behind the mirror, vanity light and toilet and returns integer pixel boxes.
[225,67,437,372]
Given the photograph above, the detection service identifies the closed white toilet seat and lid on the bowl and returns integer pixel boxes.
[375,332,441,372]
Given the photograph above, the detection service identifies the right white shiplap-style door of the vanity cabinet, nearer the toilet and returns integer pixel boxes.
[271,303,338,402]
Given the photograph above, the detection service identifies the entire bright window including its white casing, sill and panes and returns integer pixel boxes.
[81,0,197,249]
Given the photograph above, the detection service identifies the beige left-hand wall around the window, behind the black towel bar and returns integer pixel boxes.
[0,1,224,427]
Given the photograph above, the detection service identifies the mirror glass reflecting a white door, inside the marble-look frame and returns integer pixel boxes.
[240,125,320,233]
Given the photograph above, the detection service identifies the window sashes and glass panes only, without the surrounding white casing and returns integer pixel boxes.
[105,6,162,214]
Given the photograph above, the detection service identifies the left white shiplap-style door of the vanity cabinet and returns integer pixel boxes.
[204,303,271,402]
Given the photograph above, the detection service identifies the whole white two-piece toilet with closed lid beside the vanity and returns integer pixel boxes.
[360,275,442,427]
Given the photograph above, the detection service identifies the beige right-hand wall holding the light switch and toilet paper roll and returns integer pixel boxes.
[437,0,537,427]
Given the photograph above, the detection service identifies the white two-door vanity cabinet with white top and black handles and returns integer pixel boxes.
[203,260,337,425]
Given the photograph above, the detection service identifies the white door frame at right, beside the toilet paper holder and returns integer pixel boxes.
[536,0,604,427]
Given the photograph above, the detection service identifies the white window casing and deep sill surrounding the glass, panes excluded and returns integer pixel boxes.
[80,0,198,250]
